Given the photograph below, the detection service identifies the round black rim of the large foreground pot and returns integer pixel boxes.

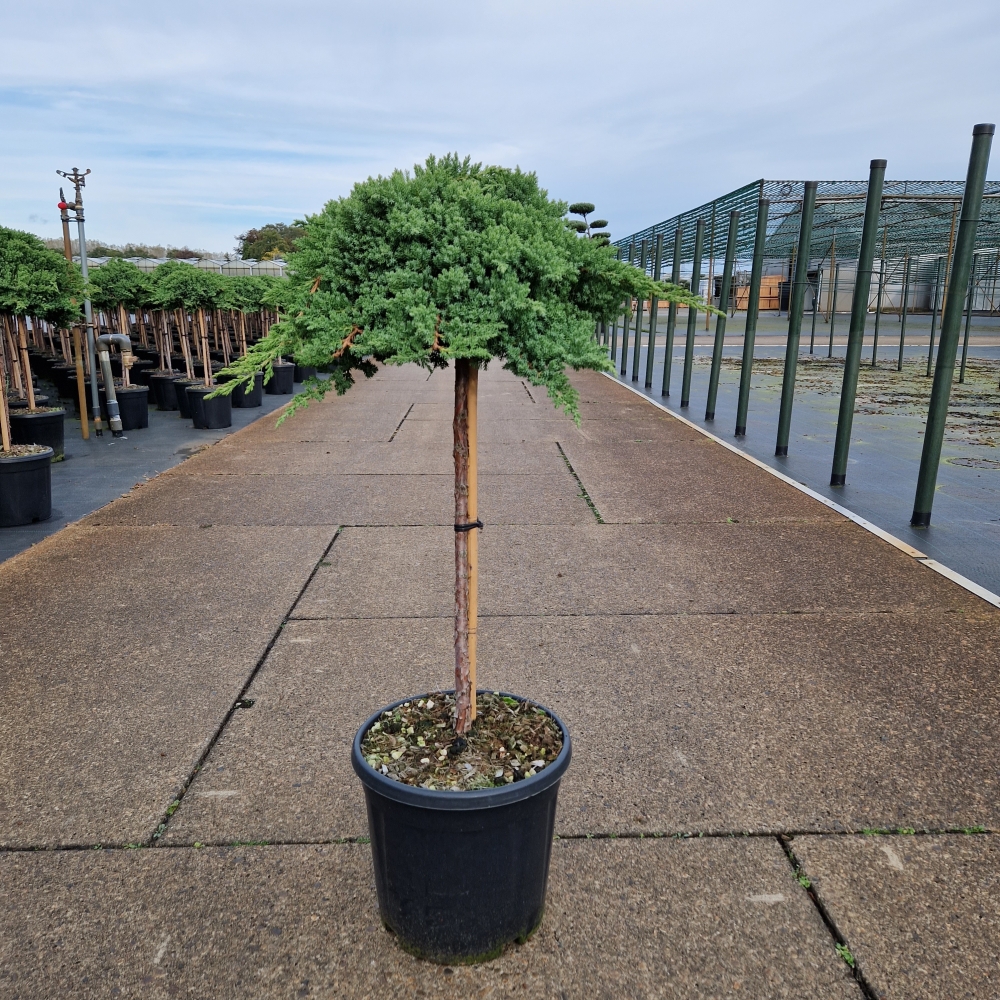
[351,688,573,812]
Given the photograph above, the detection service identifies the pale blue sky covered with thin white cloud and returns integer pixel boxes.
[0,0,1000,251]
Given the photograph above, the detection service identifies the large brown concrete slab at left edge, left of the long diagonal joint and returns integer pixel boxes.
[0,526,333,847]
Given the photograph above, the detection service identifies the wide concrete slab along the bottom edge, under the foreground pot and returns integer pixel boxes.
[0,841,858,1000]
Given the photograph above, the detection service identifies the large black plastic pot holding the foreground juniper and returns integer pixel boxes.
[351,695,571,964]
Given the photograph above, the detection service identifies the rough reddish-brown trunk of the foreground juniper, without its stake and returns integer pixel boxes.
[452,360,472,735]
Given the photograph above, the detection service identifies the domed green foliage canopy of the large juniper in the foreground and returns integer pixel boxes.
[217,155,705,416]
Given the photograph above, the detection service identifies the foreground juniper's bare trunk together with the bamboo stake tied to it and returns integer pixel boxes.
[454,361,479,734]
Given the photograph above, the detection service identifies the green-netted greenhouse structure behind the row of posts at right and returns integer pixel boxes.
[614,179,1000,318]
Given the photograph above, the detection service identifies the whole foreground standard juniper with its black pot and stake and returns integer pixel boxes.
[219,156,704,962]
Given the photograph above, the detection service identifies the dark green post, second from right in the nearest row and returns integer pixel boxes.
[830,160,885,486]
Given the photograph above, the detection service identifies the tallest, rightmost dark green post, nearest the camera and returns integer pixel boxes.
[910,125,996,528]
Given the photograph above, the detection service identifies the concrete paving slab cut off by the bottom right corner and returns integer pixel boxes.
[791,835,1000,1000]
